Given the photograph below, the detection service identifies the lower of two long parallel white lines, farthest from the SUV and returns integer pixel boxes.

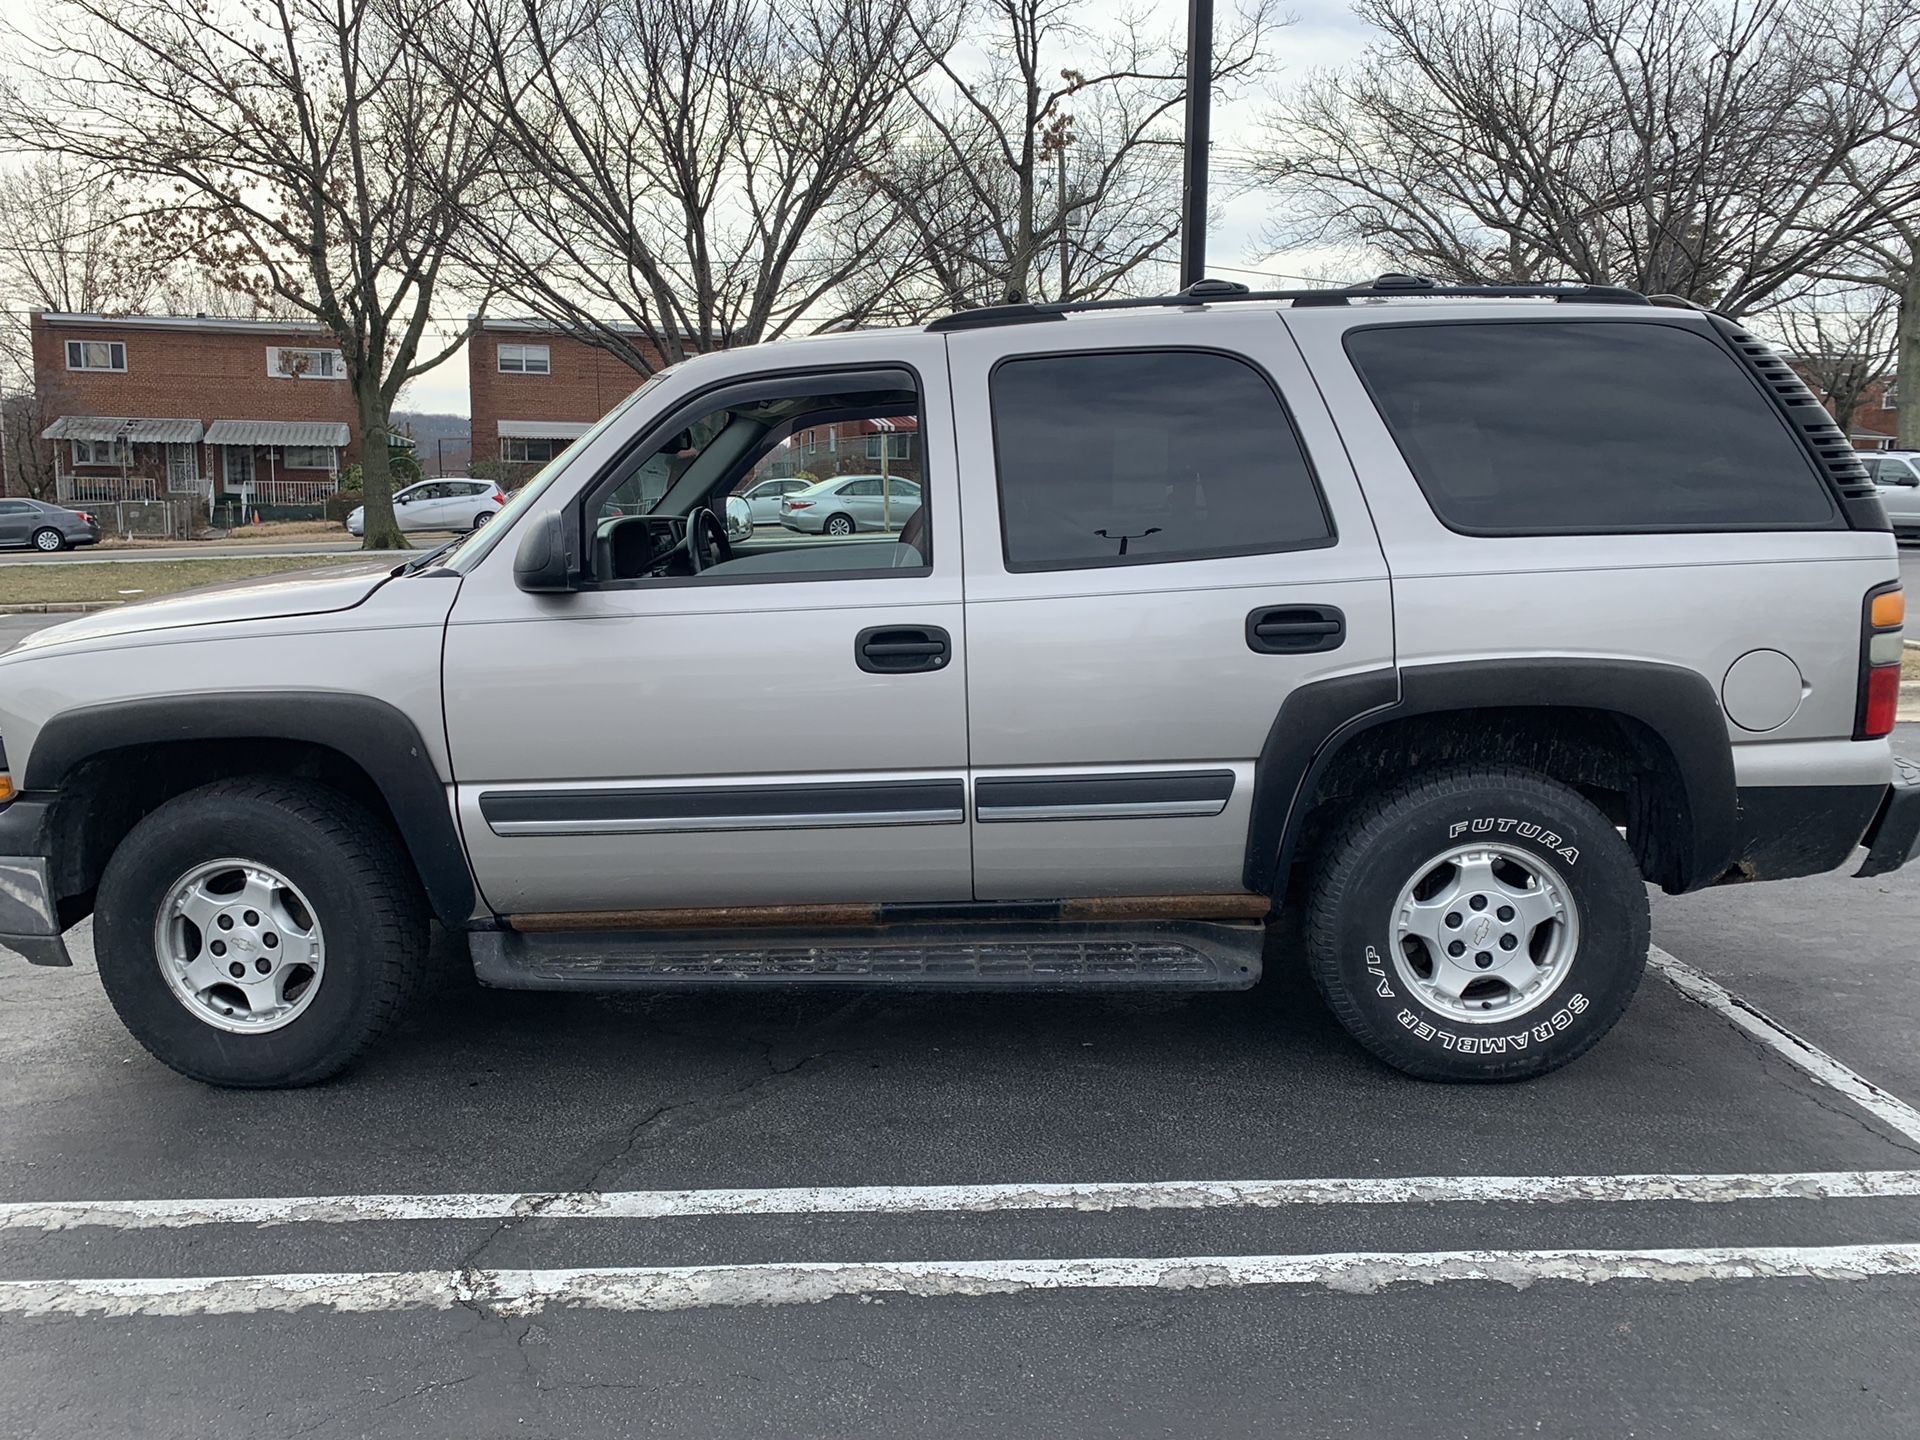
[0,1244,1920,1317]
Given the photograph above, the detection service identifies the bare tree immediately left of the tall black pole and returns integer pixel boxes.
[868,0,1277,317]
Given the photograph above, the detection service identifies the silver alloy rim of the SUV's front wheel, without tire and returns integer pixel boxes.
[154,858,326,1035]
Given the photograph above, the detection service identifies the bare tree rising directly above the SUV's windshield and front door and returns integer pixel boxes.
[449,0,945,374]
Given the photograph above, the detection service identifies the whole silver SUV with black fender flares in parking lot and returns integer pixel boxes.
[0,278,1920,1085]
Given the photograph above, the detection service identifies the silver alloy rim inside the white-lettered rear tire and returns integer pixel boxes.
[1392,843,1580,1025]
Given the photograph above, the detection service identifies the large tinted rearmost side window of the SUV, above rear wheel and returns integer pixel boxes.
[1346,321,1843,536]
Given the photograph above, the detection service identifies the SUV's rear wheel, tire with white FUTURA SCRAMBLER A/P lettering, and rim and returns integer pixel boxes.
[1306,768,1651,1081]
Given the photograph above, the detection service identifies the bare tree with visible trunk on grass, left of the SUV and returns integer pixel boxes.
[0,0,478,547]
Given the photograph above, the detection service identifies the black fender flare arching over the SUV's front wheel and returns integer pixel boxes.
[21,689,474,927]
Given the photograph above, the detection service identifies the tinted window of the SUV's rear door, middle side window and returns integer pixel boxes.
[991,349,1332,570]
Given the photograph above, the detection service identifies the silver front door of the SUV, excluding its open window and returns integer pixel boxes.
[445,336,972,912]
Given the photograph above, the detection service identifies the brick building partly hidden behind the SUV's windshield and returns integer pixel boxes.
[467,319,660,474]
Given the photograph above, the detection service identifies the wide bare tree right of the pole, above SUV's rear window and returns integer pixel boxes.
[1254,0,1907,315]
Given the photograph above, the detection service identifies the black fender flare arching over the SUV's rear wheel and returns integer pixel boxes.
[1244,657,1740,893]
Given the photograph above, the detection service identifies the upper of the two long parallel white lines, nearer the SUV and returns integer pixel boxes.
[11,1169,1920,1231]
